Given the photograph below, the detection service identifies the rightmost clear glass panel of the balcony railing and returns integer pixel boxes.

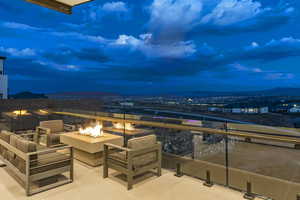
[228,133,300,200]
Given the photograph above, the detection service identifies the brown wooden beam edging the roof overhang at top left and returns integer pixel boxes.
[26,0,72,15]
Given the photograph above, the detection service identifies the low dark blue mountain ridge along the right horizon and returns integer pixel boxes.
[170,88,300,97]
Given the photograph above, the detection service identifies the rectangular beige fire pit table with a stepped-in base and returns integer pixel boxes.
[60,132,123,167]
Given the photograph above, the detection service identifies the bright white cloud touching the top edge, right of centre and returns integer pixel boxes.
[201,0,262,26]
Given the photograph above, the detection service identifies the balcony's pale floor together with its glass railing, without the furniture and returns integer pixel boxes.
[0,104,300,200]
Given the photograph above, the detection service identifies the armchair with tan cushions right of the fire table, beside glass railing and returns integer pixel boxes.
[103,135,161,190]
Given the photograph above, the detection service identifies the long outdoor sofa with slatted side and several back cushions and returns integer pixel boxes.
[0,131,73,196]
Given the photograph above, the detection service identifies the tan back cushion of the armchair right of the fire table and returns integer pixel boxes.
[127,135,157,149]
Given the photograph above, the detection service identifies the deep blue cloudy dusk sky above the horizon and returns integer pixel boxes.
[0,0,300,94]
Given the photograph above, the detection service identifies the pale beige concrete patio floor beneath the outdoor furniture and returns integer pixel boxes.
[0,162,258,200]
